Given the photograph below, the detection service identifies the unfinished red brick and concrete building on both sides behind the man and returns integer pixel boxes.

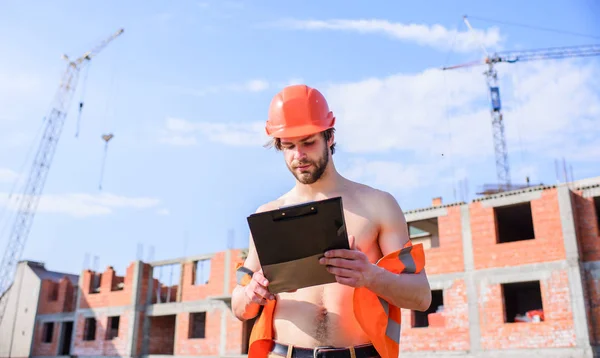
[0,177,600,357]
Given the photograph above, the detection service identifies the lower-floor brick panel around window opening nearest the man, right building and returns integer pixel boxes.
[400,280,469,352]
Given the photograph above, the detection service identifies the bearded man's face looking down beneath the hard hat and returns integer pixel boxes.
[281,134,329,184]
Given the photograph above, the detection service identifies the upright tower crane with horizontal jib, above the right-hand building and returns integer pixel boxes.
[442,15,600,194]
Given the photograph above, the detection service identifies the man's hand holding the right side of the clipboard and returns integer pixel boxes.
[319,235,379,287]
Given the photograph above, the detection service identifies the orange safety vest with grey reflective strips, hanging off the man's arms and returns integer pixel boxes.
[236,241,425,358]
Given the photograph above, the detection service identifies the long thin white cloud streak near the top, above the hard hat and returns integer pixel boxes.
[274,19,502,52]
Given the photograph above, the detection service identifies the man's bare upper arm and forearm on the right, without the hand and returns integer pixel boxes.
[367,192,431,311]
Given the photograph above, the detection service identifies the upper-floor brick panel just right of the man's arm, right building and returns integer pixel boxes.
[425,207,464,275]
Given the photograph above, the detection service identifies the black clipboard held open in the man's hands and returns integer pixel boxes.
[247,197,350,294]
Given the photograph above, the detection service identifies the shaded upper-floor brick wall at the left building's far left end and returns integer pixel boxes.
[38,277,77,314]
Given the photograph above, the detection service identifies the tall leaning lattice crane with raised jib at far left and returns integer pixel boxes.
[0,29,124,322]
